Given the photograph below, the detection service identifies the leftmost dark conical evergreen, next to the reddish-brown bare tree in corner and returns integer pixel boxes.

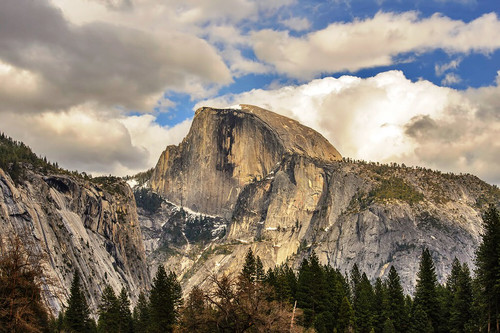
[64,271,93,333]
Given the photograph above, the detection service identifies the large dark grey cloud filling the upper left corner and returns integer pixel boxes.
[0,0,231,111]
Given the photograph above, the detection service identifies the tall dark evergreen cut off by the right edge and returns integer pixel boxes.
[476,206,500,332]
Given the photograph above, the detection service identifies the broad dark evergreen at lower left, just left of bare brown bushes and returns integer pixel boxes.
[150,265,182,333]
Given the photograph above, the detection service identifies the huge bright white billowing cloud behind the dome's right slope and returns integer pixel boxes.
[197,71,500,184]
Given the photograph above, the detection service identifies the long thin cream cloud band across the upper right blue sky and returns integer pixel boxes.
[252,12,500,80]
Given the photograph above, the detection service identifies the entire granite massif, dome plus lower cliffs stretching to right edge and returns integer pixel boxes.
[146,105,500,292]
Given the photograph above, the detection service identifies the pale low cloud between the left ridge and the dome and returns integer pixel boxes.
[0,104,191,175]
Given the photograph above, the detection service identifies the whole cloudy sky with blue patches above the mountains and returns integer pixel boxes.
[0,0,500,184]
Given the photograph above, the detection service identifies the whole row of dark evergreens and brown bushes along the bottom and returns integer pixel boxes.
[0,207,500,333]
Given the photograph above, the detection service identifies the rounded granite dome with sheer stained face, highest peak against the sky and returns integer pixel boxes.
[151,105,341,218]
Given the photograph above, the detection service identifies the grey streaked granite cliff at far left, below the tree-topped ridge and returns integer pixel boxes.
[0,169,150,312]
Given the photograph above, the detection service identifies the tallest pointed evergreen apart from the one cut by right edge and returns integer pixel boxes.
[414,248,440,330]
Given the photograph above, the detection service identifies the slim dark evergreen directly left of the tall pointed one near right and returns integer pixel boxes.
[386,266,408,332]
